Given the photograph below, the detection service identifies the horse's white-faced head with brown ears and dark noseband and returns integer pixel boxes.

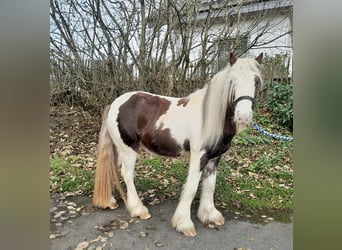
[229,53,263,128]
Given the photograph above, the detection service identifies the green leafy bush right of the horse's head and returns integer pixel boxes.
[265,82,293,130]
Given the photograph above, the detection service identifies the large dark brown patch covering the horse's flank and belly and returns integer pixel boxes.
[117,93,183,156]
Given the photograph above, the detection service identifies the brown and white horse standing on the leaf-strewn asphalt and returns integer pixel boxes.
[93,53,263,236]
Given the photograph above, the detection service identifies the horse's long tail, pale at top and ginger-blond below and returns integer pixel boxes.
[93,106,127,209]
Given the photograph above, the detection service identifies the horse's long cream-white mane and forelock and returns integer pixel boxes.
[202,58,262,147]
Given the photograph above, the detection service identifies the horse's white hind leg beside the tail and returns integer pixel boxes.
[120,148,151,219]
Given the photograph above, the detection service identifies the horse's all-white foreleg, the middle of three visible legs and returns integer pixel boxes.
[172,150,202,236]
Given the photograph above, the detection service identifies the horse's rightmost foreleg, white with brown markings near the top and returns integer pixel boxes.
[197,158,224,225]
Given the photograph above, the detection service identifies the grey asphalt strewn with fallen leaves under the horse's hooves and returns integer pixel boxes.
[50,195,293,250]
